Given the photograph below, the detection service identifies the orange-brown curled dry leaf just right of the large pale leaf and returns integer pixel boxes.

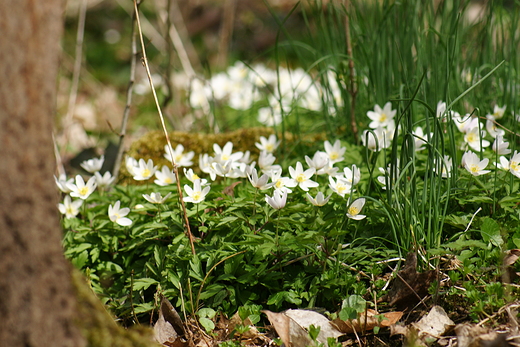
[333,309,403,334]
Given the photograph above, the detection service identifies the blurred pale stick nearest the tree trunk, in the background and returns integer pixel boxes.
[63,0,87,154]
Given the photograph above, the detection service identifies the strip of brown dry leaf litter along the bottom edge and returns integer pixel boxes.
[154,250,520,347]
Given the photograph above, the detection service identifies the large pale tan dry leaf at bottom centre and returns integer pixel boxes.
[262,310,343,347]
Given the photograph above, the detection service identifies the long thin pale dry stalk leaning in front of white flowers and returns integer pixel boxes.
[134,0,196,255]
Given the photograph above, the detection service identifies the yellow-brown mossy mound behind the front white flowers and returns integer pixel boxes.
[119,127,326,184]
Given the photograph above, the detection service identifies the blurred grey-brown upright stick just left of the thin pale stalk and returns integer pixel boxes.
[112,4,137,179]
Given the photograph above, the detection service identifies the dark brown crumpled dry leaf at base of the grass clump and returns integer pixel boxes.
[383,252,437,310]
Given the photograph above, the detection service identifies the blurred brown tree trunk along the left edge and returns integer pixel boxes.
[0,0,86,347]
